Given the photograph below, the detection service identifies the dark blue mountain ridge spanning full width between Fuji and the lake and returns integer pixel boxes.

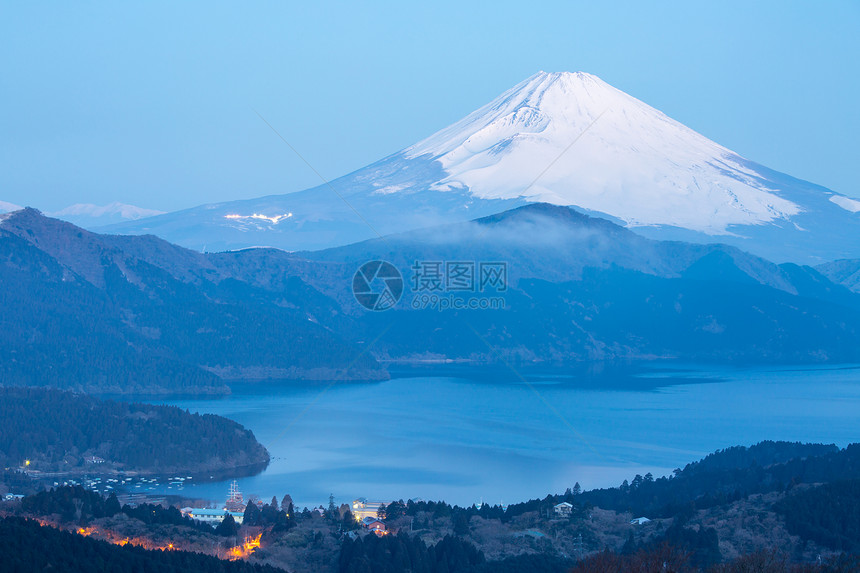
[0,203,860,393]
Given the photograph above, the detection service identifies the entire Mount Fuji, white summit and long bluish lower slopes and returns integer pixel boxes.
[99,72,860,263]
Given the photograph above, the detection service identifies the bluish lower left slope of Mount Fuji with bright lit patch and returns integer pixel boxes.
[94,168,526,252]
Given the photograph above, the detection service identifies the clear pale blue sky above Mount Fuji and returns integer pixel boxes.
[0,0,860,211]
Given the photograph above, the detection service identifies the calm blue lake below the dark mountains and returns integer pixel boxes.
[139,365,860,507]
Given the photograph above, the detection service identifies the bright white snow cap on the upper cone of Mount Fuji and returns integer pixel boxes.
[404,72,801,234]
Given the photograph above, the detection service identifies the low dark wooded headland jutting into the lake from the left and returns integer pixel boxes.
[0,387,269,473]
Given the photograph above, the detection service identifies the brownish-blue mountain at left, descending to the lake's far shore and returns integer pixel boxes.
[0,209,387,394]
